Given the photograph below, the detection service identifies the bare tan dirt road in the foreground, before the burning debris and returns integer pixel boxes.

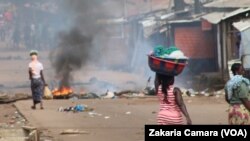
[16,97,227,141]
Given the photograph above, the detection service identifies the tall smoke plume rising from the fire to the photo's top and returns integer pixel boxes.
[50,0,121,87]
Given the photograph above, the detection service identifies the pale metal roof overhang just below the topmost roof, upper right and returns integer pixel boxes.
[202,8,250,24]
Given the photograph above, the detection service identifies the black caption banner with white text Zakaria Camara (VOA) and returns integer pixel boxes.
[145,125,250,141]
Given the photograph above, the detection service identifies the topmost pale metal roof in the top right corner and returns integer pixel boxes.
[204,0,250,8]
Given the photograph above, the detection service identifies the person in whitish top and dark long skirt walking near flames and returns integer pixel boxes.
[29,50,46,109]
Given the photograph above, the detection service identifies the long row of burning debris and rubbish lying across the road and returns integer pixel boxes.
[43,78,225,99]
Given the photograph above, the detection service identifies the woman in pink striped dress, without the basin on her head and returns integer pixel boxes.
[155,74,192,125]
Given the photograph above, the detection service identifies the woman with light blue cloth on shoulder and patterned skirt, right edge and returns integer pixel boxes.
[225,63,250,125]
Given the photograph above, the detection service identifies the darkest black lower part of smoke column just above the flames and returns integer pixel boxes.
[51,29,93,87]
